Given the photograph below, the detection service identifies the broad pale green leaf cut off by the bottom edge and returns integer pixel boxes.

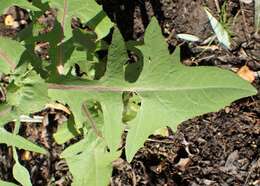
[66,142,120,186]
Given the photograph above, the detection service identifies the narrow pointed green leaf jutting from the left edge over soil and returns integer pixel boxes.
[0,127,47,154]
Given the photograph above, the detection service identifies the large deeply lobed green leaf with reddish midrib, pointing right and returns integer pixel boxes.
[49,18,256,161]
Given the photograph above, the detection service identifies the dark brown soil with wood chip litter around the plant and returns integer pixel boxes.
[0,0,260,186]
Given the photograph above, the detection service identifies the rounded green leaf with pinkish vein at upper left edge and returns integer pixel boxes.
[0,36,25,74]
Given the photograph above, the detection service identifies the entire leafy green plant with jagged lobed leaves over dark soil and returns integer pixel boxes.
[0,0,256,186]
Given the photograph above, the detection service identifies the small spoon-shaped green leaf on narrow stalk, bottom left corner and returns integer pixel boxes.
[13,147,32,186]
